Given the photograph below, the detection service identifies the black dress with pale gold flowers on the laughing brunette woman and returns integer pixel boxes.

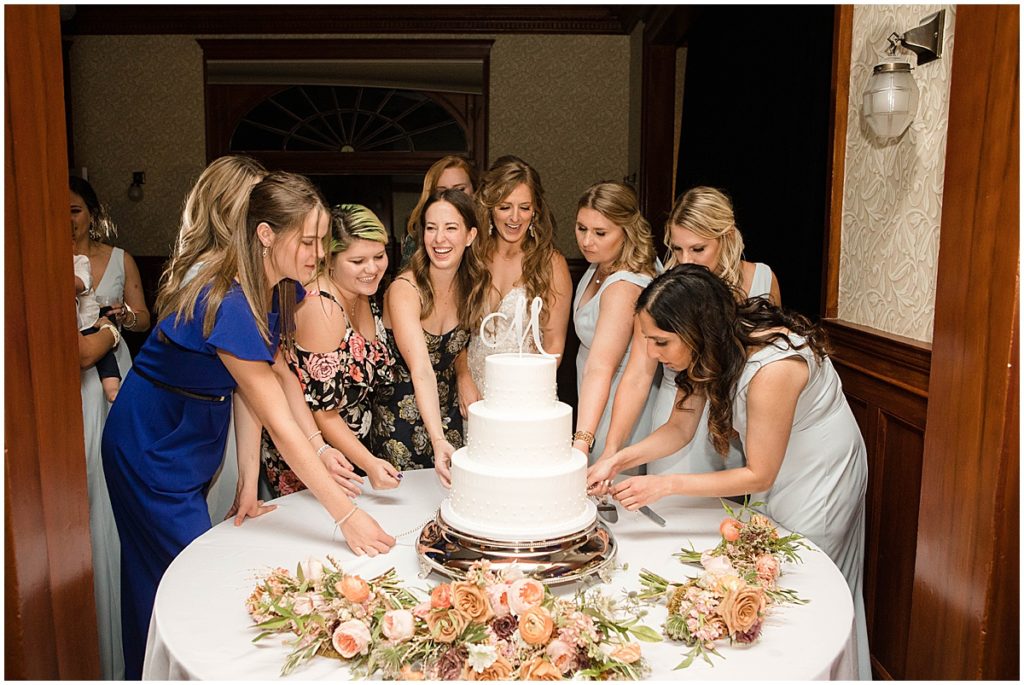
[373,327,469,471]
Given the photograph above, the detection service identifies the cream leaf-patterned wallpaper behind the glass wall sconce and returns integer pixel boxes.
[839,5,955,342]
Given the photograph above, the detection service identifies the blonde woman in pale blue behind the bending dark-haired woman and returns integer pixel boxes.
[603,186,781,473]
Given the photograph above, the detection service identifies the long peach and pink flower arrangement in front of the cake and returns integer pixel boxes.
[246,557,660,680]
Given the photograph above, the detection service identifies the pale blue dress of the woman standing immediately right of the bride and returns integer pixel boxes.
[572,264,655,463]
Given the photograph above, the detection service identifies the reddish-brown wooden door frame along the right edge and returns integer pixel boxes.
[905,5,1020,680]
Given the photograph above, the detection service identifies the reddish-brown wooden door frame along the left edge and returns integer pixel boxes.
[4,5,99,680]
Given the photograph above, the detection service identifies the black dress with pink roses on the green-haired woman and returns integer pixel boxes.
[260,290,394,498]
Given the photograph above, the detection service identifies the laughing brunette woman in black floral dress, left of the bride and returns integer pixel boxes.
[374,189,490,487]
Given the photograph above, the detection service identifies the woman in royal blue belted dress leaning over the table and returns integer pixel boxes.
[102,173,394,679]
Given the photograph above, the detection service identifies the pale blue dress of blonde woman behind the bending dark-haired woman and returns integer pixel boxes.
[647,262,771,475]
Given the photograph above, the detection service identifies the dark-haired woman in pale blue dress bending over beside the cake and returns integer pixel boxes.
[587,264,870,679]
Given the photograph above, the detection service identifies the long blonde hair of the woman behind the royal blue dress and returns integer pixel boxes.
[156,155,266,312]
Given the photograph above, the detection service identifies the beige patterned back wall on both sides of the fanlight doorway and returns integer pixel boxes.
[71,35,639,256]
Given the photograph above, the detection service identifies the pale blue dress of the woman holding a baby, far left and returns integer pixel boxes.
[81,248,131,680]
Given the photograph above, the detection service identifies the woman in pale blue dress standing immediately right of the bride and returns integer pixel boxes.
[572,182,658,464]
